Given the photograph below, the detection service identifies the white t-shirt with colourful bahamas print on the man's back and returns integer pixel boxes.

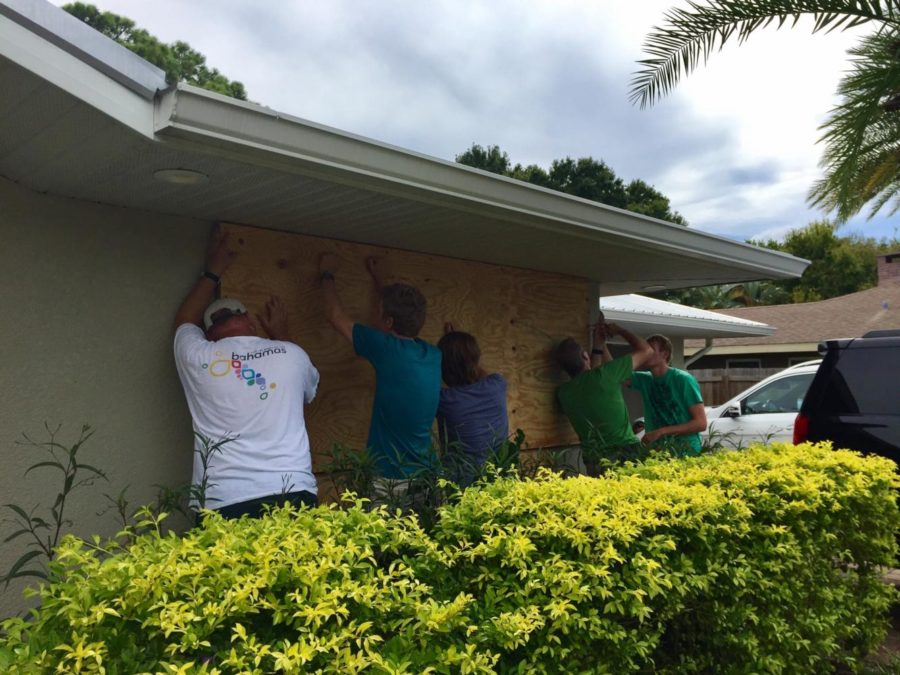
[175,324,319,509]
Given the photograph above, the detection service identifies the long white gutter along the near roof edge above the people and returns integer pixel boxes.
[155,84,809,279]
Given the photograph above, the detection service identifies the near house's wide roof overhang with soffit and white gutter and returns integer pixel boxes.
[0,0,808,294]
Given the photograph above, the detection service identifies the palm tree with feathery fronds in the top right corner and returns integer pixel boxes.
[631,0,900,222]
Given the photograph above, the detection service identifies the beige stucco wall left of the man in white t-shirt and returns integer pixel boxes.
[0,179,209,616]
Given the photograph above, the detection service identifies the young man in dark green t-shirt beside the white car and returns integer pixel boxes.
[630,335,706,457]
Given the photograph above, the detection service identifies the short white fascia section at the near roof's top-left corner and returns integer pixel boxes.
[0,0,167,101]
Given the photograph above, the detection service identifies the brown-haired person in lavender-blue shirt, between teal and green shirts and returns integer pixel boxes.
[437,323,509,488]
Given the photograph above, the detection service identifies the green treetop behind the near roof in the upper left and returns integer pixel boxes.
[62,2,247,101]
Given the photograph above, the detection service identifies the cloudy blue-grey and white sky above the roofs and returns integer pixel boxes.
[57,0,900,240]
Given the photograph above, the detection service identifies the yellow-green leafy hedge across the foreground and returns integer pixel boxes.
[0,445,900,673]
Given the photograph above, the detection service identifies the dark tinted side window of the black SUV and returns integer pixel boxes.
[820,349,900,415]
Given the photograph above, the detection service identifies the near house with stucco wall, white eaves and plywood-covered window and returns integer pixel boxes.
[0,0,807,615]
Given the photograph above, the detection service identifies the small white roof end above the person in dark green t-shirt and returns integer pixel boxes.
[600,294,775,338]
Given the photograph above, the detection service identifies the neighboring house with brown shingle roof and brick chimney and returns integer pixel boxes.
[685,253,900,370]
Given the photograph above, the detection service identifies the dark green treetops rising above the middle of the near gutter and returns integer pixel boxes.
[456,143,687,225]
